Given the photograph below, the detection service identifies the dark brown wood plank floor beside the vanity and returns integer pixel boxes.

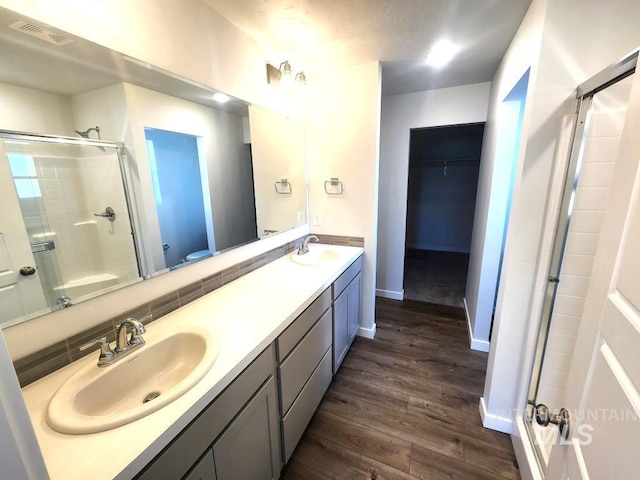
[281,299,520,480]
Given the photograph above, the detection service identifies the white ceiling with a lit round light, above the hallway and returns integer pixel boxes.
[204,0,531,95]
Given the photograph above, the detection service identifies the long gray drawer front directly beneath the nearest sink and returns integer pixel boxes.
[136,345,275,480]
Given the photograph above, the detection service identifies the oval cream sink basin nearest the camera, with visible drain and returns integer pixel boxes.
[47,327,219,434]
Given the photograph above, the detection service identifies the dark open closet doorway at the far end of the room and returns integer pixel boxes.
[404,122,485,307]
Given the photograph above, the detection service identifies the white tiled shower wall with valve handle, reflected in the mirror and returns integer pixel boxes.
[23,145,138,300]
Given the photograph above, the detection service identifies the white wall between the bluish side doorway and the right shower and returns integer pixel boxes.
[481,0,640,476]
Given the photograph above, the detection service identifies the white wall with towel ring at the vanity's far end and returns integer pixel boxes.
[305,62,381,336]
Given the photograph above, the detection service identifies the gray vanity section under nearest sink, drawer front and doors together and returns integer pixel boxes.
[137,346,282,480]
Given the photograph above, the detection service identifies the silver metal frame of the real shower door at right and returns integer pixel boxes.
[524,49,640,472]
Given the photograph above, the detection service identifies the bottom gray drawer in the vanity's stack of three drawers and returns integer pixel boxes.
[282,349,331,463]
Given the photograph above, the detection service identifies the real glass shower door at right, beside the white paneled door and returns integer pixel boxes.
[525,58,635,471]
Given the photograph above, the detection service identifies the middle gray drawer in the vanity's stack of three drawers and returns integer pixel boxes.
[278,310,332,415]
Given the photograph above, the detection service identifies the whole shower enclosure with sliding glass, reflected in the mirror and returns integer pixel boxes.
[0,131,140,326]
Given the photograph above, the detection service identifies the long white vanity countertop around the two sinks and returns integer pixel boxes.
[22,244,363,480]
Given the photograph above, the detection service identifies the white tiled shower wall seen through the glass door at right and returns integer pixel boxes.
[536,79,630,410]
